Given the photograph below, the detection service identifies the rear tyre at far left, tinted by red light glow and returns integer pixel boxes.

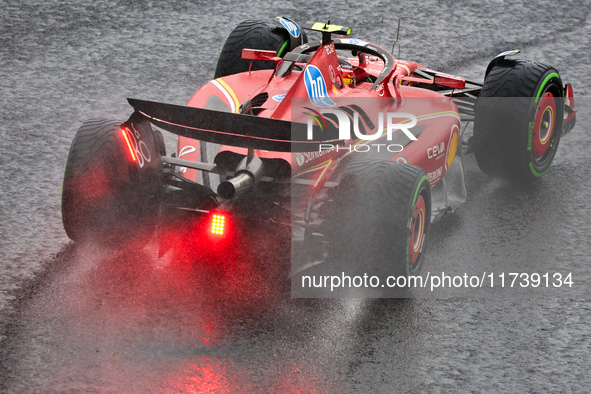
[62,120,161,247]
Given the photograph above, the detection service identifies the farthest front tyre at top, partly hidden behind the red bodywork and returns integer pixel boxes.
[214,17,308,78]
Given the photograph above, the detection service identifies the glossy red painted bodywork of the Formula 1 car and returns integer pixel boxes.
[177,39,465,186]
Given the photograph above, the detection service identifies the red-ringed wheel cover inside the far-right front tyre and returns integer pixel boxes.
[532,92,556,159]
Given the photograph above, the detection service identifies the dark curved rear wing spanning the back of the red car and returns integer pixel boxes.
[127,99,344,152]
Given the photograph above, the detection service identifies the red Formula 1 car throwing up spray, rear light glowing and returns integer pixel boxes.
[62,18,575,286]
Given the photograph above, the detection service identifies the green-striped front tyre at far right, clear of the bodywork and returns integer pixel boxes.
[473,59,564,182]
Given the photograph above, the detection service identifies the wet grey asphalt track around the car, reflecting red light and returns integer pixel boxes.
[0,1,591,392]
